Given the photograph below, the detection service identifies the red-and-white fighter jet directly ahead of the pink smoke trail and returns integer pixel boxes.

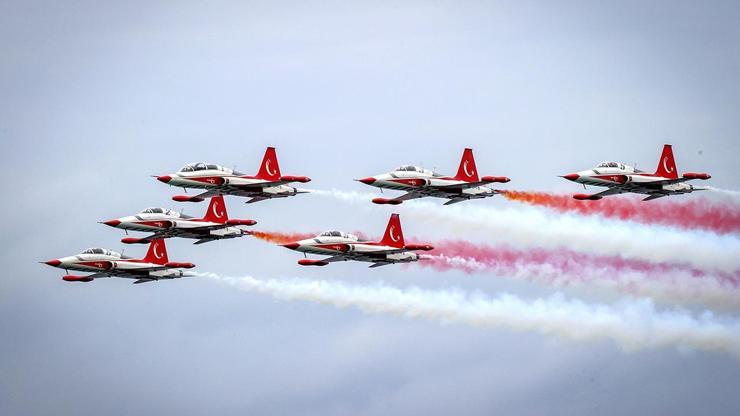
[281,214,434,267]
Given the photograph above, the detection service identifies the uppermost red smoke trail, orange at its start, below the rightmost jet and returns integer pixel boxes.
[500,191,740,234]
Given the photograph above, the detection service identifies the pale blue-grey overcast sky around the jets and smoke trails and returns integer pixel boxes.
[0,0,740,415]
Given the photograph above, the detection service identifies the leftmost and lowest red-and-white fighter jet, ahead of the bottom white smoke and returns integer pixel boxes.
[44,239,195,283]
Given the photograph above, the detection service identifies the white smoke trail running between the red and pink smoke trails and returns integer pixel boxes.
[314,190,740,272]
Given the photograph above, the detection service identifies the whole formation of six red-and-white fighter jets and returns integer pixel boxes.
[43,144,711,283]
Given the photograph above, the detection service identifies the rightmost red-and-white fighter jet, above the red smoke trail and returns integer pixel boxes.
[562,144,712,201]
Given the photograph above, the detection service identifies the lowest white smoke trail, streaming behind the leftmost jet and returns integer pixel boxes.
[200,273,740,358]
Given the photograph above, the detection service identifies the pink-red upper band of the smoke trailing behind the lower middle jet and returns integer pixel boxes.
[420,241,740,288]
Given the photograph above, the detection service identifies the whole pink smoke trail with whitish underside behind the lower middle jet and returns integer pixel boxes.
[420,241,740,310]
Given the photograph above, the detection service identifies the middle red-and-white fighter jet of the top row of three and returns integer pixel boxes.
[355,149,510,205]
